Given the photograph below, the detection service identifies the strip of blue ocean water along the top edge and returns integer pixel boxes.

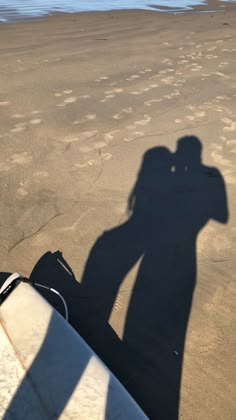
[0,0,236,22]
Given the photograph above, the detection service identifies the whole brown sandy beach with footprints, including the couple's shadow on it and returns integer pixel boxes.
[0,2,236,420]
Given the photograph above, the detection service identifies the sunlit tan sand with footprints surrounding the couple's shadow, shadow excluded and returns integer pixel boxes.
[0,5,236,420]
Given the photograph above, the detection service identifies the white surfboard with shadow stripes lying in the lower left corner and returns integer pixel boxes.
[0,283,147,420]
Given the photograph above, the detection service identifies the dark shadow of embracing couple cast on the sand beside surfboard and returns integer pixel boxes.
[28,136,228,420]
